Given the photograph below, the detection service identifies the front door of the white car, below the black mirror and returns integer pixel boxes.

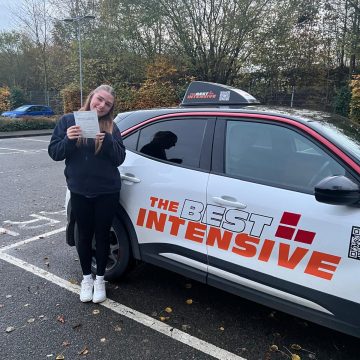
[206,116,360,327]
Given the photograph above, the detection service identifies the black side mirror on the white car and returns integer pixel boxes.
[315,175,360,205]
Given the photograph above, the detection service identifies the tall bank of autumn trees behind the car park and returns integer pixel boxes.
[0,0,360,112]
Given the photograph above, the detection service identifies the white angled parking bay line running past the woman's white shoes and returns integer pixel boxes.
[0,227,246,360]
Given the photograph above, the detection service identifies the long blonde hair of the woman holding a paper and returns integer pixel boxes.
[77,84,115,154]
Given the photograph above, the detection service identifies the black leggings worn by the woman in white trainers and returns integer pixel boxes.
[71,192,120,276]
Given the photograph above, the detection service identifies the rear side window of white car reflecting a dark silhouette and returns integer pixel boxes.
[124,118,206,167]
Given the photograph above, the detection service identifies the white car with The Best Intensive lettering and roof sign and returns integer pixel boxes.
[66,81,360,337]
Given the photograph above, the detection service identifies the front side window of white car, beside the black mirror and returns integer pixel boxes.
[225,121,345,193]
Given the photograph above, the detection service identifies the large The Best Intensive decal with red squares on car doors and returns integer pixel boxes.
[136,196,341,281]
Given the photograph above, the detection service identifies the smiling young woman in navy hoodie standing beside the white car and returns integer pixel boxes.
[48,85,125,303]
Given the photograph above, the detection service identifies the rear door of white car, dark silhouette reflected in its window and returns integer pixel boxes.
[119,117,215,282]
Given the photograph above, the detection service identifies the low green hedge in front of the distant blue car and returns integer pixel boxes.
[0,116,57,132]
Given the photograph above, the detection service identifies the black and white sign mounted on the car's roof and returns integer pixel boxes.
[180,81,260,107]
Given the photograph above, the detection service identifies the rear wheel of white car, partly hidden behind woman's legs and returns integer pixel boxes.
[75,218,130,281]
